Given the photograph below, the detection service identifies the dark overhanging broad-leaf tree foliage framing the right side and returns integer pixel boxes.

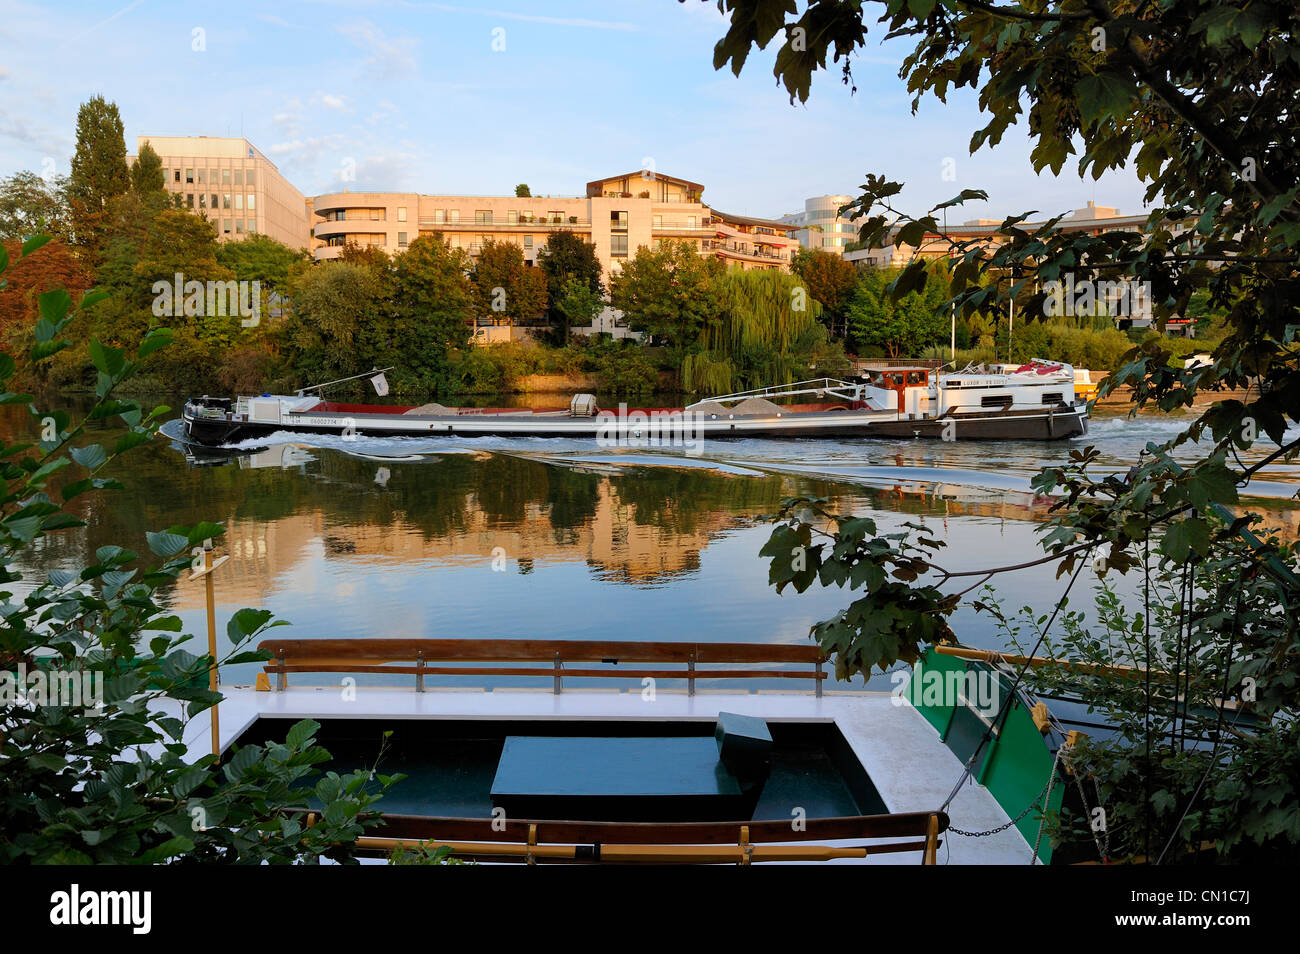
[715,0,1300,859]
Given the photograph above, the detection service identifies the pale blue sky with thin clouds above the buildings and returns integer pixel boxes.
[0,0,1143,222]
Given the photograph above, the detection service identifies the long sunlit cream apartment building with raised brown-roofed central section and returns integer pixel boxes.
[311,172,798,279]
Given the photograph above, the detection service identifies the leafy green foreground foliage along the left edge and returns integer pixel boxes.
[0,243,394,864]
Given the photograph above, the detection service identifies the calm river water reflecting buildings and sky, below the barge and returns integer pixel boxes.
[4,395,1300,682]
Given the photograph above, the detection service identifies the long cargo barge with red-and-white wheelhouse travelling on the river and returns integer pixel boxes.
[182,360,1088,448]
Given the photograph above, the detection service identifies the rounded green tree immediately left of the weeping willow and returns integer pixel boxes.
[610,242,724,373]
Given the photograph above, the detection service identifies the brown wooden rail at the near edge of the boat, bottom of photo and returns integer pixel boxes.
[356,811,949,864]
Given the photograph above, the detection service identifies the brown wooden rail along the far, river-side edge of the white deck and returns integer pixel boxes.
[259,638,827,697]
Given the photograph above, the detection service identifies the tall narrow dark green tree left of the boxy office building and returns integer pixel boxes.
[68,96,131,264]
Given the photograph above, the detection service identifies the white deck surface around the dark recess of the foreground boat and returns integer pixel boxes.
[172,686,1031,864]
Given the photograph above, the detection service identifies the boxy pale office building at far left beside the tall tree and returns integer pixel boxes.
[136,136,311,248]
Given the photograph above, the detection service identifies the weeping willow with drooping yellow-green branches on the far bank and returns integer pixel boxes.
[681,268,823,394]
